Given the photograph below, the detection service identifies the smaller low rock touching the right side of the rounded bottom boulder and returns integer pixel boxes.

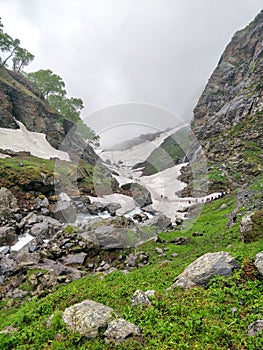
[104,318,141,343]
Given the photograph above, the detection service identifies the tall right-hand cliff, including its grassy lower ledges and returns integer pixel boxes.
[192,11,263,184]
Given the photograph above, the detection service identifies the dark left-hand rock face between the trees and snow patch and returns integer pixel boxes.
[0,68,98,165]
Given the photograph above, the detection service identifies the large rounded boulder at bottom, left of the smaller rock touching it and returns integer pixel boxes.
[63,300,114,338]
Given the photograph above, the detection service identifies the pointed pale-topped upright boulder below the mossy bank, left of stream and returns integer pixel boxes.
[50,192,76,223]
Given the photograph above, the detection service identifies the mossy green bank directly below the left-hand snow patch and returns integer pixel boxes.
[0,152,98,195]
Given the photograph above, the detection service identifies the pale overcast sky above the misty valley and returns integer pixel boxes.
[0,0,262,145]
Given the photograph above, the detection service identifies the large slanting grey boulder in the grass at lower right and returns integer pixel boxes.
[169,252,239,289]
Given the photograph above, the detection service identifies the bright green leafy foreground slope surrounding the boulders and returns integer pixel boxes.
[0,194,263,350]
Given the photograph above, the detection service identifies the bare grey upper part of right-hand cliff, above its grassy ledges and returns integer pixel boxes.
[194,11,263,134]
